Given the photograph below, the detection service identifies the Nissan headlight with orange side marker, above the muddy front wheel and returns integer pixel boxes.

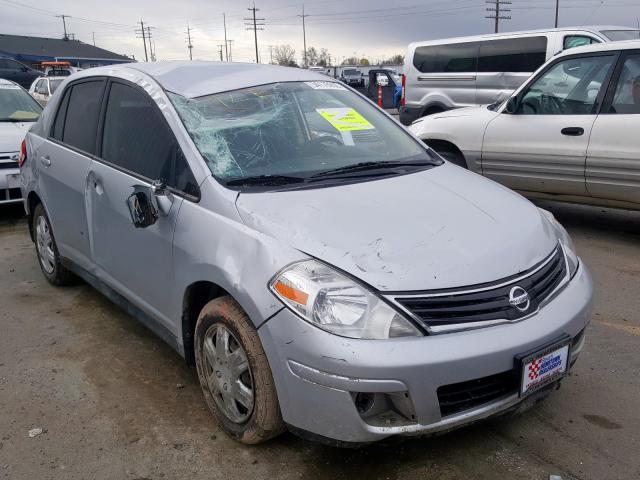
[269,260,422,340]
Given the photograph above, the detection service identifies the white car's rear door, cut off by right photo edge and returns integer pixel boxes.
[586,50,640,203]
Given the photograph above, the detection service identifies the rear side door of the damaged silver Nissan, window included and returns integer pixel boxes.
[34,77,106,269]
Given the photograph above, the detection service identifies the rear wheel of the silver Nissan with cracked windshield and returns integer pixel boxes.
[33,203,77,286]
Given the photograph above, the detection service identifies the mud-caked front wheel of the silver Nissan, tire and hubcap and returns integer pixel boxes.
[194,296,285,444]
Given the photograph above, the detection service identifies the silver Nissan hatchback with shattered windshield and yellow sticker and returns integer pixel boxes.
[21,62,592,443]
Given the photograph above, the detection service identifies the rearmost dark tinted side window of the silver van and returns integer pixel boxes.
[413,42,478,73]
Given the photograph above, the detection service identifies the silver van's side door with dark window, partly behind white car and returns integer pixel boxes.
[476,35,547,104]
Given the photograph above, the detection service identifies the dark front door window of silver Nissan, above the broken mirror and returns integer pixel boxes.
[102,83,197,195]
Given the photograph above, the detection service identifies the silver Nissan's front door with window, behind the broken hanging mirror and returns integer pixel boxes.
[89,81,192,334]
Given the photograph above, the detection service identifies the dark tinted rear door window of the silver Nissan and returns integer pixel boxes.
[62,80,104,153]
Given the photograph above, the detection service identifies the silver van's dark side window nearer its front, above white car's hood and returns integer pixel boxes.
[478,37,547,72]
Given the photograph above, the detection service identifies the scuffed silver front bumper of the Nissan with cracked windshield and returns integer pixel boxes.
[259,264,593,443]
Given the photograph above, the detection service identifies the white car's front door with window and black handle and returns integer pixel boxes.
[482,54,616,196]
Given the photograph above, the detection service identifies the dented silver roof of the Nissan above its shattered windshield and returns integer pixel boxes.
[72,61,336,98]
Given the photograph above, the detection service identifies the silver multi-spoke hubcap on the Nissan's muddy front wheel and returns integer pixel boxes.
[203,324,254,423]
